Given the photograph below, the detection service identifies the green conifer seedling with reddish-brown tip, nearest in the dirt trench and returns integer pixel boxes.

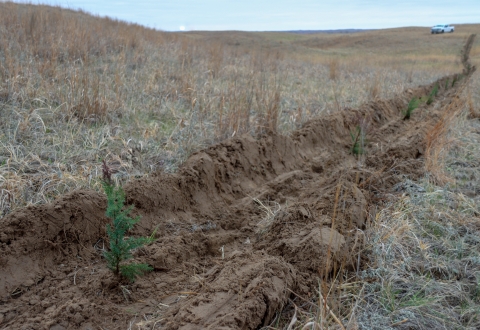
[103,161,153,282]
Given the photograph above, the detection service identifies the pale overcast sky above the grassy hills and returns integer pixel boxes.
[33,0,480,31]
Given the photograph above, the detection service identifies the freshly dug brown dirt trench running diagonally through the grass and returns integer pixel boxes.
[0,72,468,330]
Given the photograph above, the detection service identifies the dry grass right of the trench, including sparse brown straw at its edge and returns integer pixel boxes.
[268,72,480,330]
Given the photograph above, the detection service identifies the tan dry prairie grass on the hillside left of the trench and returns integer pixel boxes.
[0,2,480,217]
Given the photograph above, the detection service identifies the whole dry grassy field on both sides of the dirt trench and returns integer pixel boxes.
[0,2,480,329]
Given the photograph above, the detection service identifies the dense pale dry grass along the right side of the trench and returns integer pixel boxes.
[355,85,480,329]
